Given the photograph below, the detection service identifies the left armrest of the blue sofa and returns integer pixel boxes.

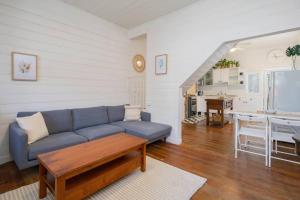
[9,122,28,169]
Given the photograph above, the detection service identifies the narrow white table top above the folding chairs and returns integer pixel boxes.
[228,110,300,120]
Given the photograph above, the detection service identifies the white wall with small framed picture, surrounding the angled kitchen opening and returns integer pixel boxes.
[129,0,300,143]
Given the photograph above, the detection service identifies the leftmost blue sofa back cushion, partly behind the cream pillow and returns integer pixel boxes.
[17,109,73,134]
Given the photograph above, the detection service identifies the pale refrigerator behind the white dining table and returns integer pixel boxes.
[266,70,300,112]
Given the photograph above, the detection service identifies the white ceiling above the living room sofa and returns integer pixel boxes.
[62,0,198,29]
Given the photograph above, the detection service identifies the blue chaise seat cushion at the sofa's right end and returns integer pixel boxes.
[112,121,172,142]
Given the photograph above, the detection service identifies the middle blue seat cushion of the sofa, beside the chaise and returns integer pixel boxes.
[76,124,125,140]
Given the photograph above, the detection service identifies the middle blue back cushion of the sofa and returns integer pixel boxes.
[72,106,109,130]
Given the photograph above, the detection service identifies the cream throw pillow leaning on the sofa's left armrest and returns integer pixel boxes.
[16,112,49,144]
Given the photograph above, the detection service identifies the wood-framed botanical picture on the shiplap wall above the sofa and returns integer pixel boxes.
[11,52,37,81]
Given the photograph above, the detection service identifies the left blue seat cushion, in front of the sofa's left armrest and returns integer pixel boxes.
[28,132,87,160]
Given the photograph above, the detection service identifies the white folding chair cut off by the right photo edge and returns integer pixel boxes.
[269,117,300,167]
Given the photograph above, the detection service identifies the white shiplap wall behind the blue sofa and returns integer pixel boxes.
[0,0,144,163]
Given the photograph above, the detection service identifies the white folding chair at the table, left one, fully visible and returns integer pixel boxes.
[235,115,269,166]
